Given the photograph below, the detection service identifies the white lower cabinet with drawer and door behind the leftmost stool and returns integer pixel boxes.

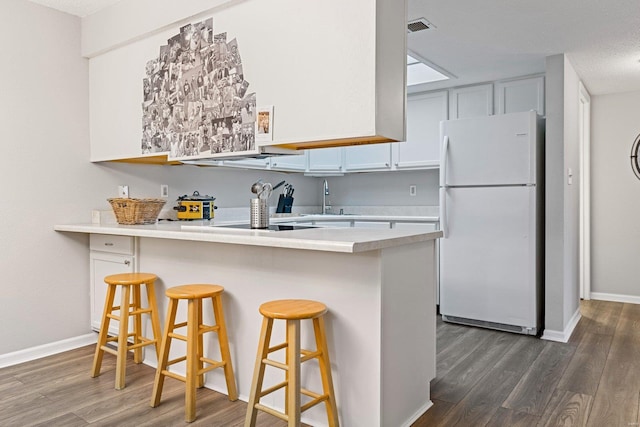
[89,234,137,334]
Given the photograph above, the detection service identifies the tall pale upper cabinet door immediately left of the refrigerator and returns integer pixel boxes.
[393,91,448,169]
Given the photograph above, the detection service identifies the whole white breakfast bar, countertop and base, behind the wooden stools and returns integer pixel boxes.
[55,222,442,427]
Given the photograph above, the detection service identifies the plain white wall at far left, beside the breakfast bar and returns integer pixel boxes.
[0,0,95,354]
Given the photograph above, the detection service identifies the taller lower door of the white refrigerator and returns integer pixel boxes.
[440,187,538,328]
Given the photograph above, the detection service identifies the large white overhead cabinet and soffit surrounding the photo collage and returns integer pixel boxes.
[88,0,407,161]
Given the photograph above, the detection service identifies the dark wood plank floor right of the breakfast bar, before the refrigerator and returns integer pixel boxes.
[413,301,640,427]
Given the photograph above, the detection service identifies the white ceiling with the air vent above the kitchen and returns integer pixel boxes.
[22,0,640,95]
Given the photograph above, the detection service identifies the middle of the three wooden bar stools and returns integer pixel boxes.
[151,285,238,422]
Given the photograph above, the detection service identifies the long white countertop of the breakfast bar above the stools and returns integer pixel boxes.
[54,221,442,253]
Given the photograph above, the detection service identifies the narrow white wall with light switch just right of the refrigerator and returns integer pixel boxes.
[545,54,580,334]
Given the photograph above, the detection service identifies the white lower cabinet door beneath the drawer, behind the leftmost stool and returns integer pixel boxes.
[89,251,135,334]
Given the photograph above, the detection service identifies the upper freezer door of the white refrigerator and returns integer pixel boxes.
[440,111,540,186]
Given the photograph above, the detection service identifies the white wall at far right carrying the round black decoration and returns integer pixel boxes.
[591,92,640,302]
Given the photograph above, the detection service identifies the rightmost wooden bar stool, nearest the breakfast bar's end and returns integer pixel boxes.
[244,300,339,427]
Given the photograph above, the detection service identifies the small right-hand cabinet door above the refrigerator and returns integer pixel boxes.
[496,76,544,116]
